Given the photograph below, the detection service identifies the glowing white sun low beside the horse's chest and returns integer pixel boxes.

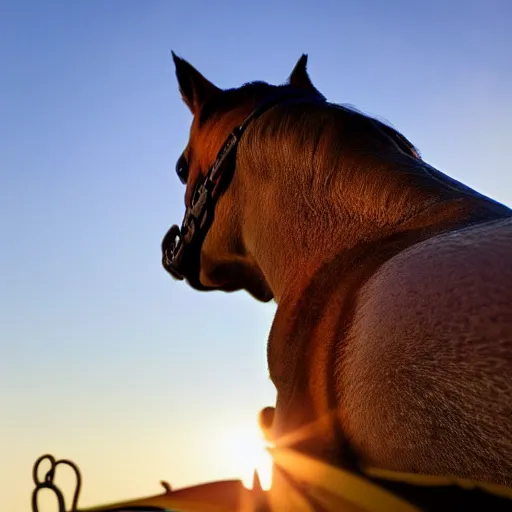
[224,427,272,490]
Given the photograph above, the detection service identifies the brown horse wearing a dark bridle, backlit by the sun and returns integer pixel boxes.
[162,54,512,485]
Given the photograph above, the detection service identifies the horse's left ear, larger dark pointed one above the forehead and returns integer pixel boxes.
[171,52,221,115]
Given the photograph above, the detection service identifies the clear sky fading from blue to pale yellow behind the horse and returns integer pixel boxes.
[0,0,512,512]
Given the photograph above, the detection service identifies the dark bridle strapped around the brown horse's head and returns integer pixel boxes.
[162,87,325,290]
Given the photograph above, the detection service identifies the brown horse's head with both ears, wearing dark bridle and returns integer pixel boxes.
[162,53,323,302]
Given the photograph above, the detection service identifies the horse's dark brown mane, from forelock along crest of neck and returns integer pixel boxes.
[200,82,484,224]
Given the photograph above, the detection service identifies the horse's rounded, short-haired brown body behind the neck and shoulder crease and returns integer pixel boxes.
[338,219,512,485]
